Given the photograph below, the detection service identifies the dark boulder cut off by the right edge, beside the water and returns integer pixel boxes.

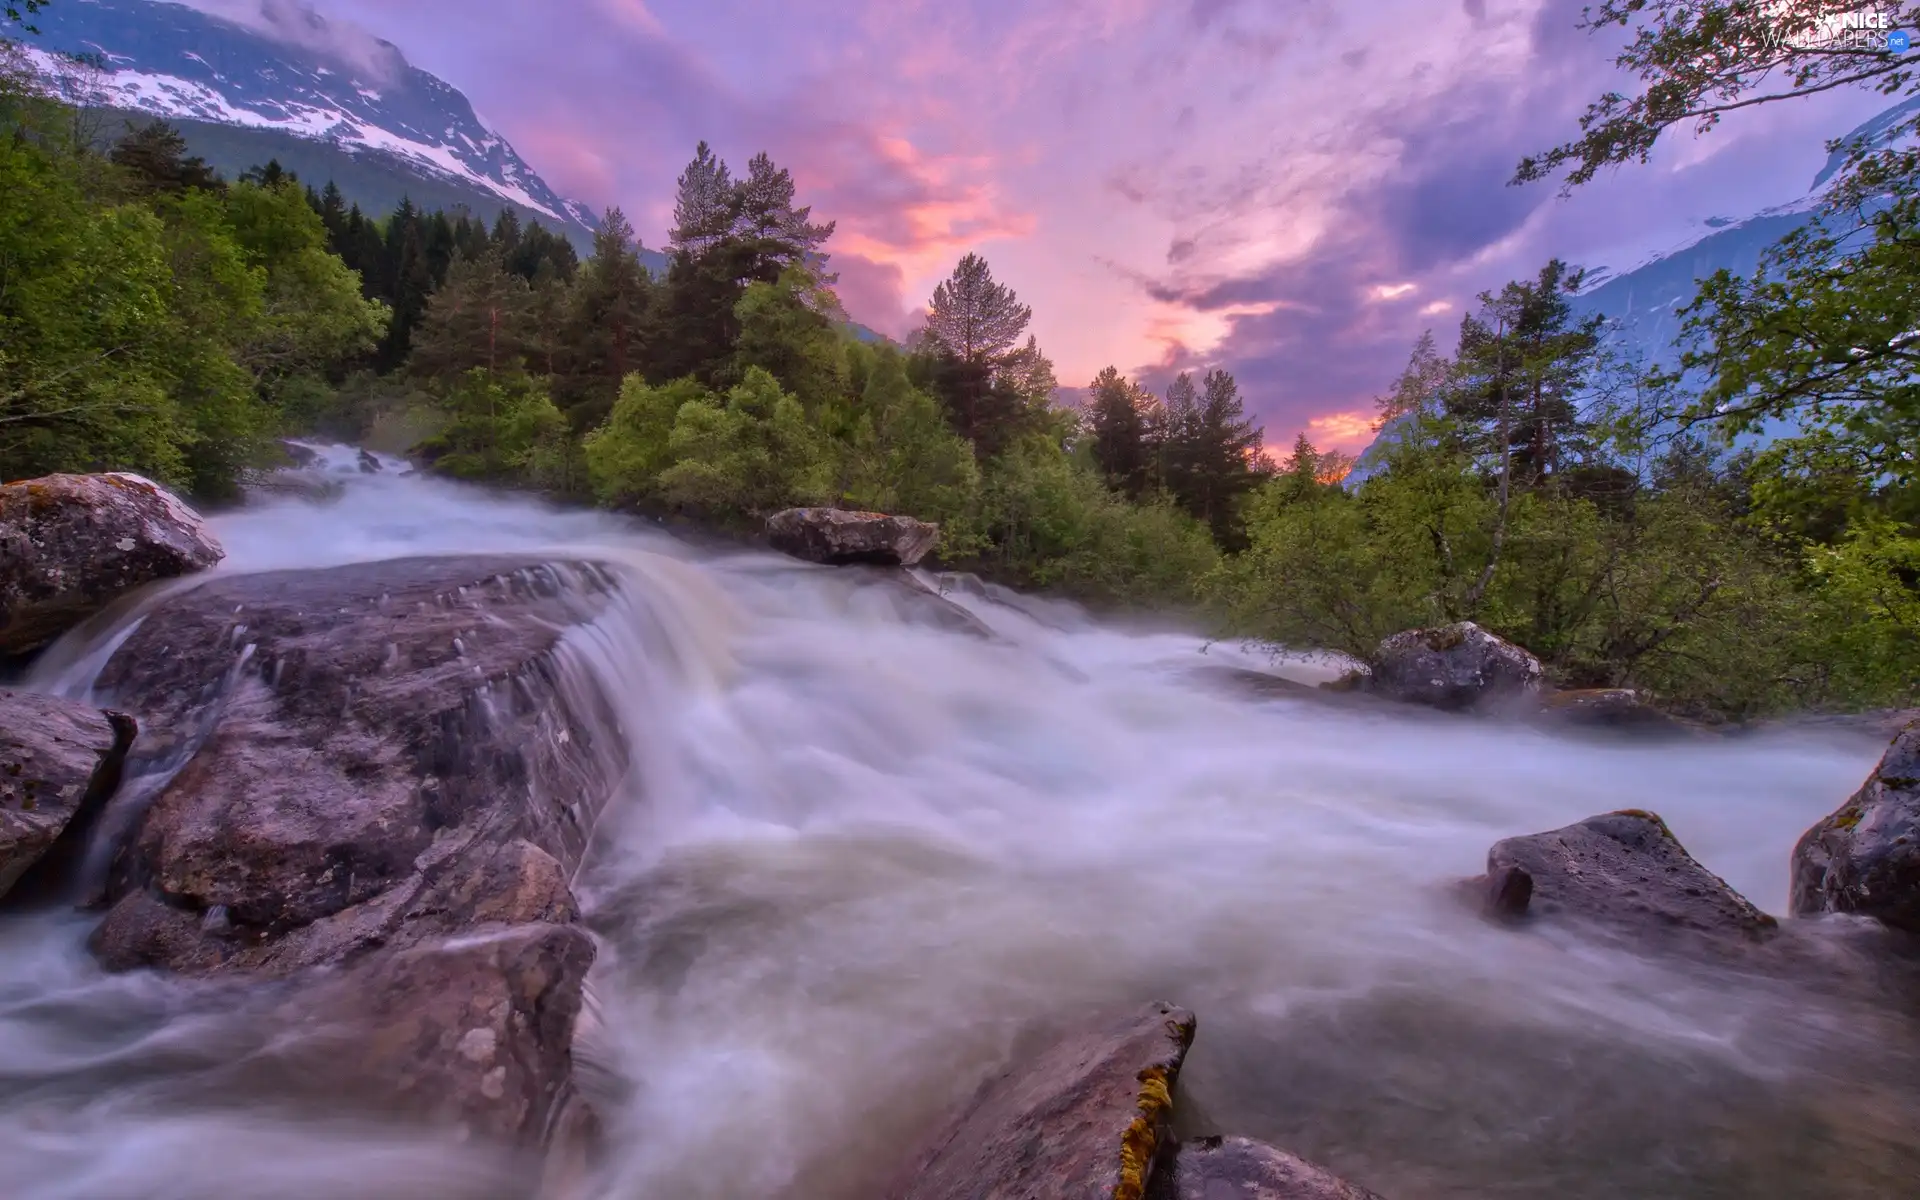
[1791,722,1920,933]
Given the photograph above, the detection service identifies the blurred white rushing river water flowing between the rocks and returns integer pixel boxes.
[0,451,1920,1200]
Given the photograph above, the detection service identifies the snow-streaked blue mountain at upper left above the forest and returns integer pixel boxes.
[8,0,597,236]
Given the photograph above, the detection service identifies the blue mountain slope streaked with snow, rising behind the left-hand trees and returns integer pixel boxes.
[8,0,597,242]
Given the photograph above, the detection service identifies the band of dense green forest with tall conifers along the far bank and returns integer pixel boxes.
[0,7,1920,718]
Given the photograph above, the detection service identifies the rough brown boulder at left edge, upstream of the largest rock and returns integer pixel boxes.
[0,472,227,655]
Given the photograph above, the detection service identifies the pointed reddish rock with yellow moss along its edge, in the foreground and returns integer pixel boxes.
[889,1004,1194,1200]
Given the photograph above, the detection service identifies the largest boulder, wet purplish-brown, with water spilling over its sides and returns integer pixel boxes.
[94,557,628,1140]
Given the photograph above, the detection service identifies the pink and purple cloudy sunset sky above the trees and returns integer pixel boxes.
[190,0,1885,449]
